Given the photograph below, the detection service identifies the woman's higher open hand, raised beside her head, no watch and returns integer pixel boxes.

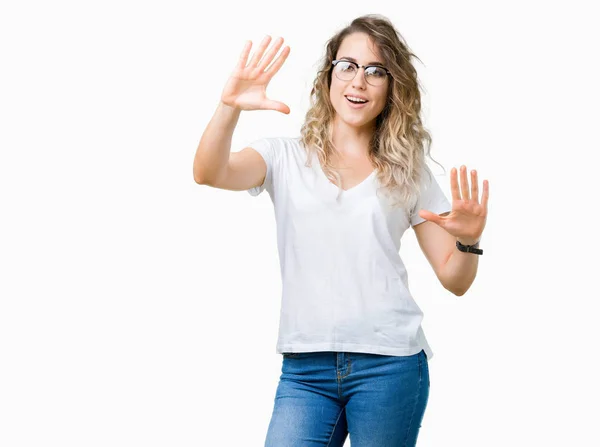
[221,36,290,114]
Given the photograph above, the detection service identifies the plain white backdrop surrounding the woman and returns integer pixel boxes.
[0,0,600,447]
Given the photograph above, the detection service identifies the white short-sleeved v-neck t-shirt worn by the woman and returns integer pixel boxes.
[248,137,452,359]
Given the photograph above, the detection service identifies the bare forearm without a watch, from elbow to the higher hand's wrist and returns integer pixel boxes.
[194,102,241,183]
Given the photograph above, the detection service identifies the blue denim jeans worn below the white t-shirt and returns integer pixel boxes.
[265,351,429,447]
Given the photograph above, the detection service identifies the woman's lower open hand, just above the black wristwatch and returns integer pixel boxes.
[419,165,489,245]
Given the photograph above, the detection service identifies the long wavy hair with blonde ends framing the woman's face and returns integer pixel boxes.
[300,14,443,210]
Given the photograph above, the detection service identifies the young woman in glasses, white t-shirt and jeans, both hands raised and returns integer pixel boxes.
[194,15,488,447]
